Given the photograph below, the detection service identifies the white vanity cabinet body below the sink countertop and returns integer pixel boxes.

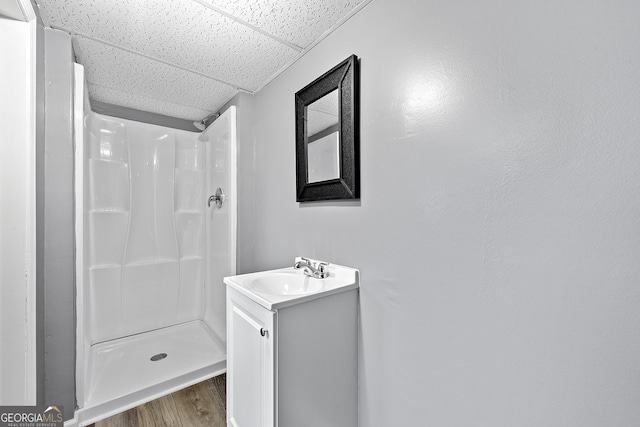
[225,266,358,427]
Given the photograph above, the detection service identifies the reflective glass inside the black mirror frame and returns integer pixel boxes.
[306,89,340,183]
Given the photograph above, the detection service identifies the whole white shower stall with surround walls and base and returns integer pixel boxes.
[75,66,236,425]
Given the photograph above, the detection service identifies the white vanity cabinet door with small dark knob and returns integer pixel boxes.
[227,289,275,427]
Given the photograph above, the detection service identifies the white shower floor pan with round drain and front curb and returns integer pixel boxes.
[76,320,227,425]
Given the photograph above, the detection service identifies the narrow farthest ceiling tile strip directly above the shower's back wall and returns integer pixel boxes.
[87,83,210,121]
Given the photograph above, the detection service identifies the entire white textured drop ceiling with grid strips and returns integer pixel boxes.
[36,0,371,120]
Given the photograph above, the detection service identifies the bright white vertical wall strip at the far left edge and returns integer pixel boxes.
[0,17,36,405]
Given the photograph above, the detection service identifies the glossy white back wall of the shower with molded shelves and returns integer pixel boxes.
[89,114,204,344]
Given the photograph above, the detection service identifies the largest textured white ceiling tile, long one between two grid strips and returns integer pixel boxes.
[39,0,298,91]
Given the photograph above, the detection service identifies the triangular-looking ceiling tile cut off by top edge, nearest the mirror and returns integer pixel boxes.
[206,0,370,48]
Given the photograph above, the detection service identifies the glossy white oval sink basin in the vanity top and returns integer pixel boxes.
[247,271,324,295]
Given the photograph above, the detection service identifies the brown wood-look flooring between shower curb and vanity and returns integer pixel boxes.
[88,374,227,427]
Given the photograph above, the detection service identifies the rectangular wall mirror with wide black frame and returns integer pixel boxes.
[295,55,360,202]
